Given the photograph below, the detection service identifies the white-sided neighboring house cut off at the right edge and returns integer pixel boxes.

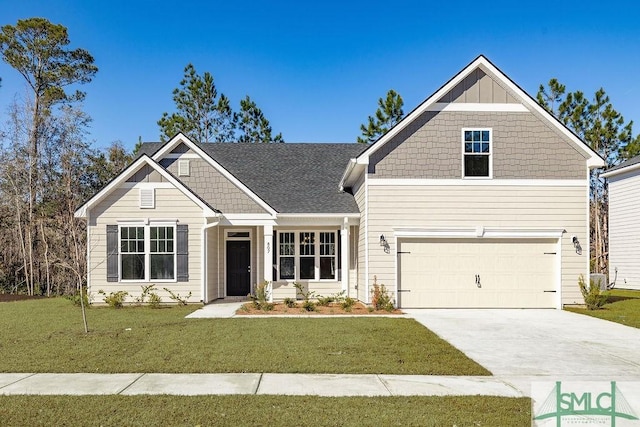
[600,156,640,289]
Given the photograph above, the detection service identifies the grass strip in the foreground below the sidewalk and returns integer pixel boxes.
[0,396,531,427]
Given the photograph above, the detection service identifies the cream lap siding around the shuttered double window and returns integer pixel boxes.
[88,188,204,303]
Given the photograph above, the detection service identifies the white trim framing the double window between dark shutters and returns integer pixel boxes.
[118,220,178,283]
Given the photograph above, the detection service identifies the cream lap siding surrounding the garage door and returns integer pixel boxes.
[367,186,589,304]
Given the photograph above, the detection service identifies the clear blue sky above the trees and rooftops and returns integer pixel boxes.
[0,0,640,152]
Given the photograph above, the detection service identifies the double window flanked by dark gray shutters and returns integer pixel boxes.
[120,225,176,281]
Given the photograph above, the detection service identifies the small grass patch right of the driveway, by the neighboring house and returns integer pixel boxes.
[567,289,640,328]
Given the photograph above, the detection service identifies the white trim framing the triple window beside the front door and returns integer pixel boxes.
[274,228,341,283]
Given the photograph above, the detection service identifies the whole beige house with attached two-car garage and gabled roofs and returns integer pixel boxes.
[76,56,604,308]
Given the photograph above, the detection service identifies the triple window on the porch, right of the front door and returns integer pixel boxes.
[274,231,339,280]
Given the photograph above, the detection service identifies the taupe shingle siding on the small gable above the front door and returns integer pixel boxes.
[161,158,266,213]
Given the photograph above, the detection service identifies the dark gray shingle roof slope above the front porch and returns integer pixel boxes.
[141,136,366,214]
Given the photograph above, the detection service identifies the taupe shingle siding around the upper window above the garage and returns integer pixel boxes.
[369,112,586,179]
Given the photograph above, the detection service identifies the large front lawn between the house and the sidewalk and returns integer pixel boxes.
[0,299,490,375]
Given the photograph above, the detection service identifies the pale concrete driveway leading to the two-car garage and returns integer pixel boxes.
[404,309,640,385]
